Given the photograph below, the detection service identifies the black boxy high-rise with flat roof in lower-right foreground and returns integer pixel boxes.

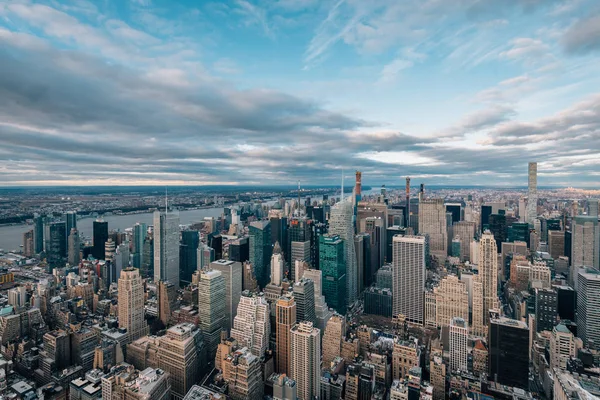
[488,318,529,390]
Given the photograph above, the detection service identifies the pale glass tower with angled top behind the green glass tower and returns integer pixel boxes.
[328,201,358,309]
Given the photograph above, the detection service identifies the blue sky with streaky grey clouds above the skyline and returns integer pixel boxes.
[0,0,600,188]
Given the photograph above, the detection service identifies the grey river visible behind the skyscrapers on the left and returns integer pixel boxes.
[0,207,223,251]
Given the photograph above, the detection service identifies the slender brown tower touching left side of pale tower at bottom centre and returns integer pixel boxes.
[275,296,296,375]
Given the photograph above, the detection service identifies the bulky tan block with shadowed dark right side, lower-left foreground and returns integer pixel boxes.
[157,323,206,399]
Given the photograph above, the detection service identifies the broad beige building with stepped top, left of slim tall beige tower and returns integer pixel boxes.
[433,275,469,327]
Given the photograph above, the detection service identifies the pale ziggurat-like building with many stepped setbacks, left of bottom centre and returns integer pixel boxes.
[231,291,271,358]
